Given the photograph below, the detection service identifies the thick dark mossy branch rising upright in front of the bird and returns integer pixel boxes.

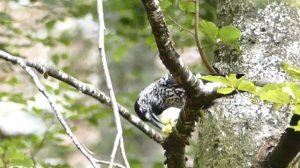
[142,0,220,168]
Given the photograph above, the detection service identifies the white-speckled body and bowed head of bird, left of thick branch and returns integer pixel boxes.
[134,74,185,128]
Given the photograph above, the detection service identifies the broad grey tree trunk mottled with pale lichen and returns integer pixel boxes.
[194,0,300,168]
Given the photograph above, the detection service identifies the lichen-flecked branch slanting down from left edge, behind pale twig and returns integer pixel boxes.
[0,50,164,144]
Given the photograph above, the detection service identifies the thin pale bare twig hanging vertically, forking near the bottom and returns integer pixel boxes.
[97,0,130,168]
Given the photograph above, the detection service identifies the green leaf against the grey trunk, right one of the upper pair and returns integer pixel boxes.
[219,26,242,50]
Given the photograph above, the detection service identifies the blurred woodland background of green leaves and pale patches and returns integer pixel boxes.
[0,0,217,168]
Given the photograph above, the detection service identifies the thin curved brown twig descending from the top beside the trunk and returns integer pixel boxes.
[195,0,217,74]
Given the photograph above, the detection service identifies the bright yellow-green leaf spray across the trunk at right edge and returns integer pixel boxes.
[202,64,300,127]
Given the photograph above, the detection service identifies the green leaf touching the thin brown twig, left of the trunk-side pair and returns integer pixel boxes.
[200,20,219,43]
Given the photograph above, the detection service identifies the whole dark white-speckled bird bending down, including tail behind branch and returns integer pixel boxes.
[134,74,244,130]
